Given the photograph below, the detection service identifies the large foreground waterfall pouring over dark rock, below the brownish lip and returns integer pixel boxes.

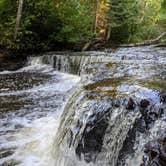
[55,85,165,166]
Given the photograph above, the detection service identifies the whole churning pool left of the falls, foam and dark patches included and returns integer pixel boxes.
[0,57,80,166]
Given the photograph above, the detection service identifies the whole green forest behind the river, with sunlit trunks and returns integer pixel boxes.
[0,0,166,52]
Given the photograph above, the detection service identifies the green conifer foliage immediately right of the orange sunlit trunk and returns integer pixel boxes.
[108,0,139,42]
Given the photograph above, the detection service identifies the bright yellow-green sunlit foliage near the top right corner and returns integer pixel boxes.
[131,0,164,42]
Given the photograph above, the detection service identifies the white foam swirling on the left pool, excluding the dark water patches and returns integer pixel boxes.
[0,58,80,166]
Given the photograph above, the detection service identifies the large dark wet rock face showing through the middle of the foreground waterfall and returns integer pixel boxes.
[76,110,109,163]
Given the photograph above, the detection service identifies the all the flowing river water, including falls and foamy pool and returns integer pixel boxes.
[0,46,166,166]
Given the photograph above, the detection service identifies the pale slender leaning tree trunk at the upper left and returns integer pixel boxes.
[14,0,24,40]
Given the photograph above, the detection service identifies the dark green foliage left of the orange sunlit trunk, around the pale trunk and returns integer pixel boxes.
[0,0,91,51]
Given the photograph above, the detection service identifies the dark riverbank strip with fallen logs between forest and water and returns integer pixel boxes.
[0,39,166,59]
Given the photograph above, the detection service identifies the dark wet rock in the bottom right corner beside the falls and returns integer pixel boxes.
[141,134,166,166]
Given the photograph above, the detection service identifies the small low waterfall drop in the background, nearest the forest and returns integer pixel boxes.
[42,53,110,75]
